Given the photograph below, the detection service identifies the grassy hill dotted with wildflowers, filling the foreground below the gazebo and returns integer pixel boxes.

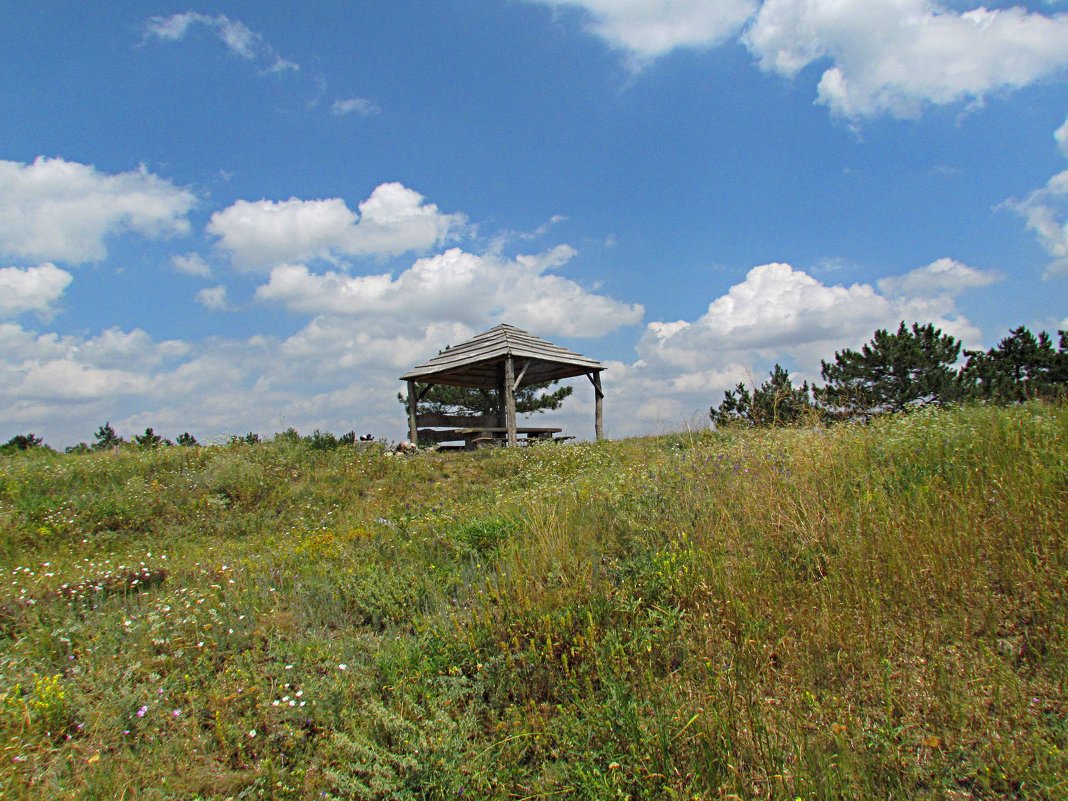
[0,406,1068,799]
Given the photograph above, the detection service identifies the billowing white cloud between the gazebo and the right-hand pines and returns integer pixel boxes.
[607,258,999,434]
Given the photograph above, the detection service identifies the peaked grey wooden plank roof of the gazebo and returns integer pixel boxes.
[401,324,604,389]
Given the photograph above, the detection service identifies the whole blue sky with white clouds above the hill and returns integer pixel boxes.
[0,0,1068,446]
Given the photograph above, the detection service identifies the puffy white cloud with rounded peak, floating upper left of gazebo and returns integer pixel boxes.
[207,183,465,269]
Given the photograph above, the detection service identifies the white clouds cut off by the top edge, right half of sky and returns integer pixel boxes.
[529,0,1068,120]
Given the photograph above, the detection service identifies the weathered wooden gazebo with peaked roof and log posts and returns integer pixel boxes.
[401,324,604,445]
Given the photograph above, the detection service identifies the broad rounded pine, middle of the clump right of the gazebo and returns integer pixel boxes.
[816,320,960,418]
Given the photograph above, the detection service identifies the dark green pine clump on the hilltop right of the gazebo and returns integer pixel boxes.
[709,320,1068,426]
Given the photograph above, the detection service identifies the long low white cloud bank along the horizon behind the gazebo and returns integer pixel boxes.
[0,254,996,445]
